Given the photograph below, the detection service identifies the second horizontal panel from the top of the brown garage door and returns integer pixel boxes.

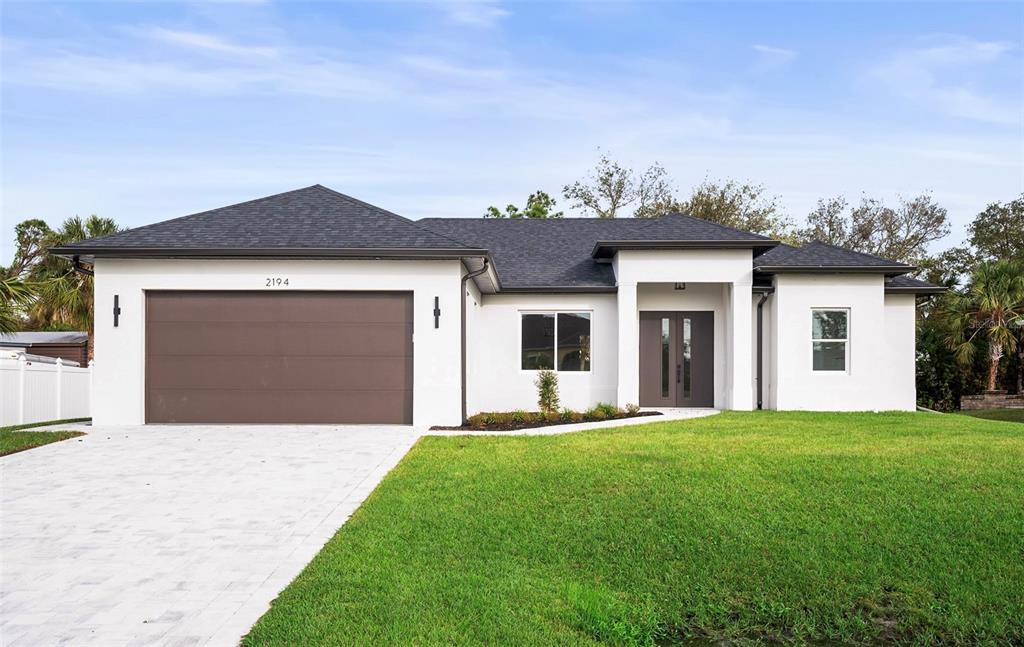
[150,321,413,357]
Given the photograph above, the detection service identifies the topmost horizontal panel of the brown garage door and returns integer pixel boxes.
[146,292,412,324]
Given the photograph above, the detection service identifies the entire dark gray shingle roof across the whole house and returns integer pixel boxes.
[52,184,942,291]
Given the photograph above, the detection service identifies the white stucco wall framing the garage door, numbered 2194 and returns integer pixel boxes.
[93,259,462,425]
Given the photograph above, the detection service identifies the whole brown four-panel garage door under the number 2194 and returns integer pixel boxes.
[145,292,413,424]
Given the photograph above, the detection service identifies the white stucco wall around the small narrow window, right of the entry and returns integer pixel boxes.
[770,274,915,411]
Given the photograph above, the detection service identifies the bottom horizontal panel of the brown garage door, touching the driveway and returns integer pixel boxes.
[151,389,412,425]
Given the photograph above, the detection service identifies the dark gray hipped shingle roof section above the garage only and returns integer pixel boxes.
[51,184,475,254]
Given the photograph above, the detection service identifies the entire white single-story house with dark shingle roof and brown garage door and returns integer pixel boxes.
[52,185,939,426]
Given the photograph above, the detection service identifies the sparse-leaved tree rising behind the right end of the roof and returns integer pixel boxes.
[799,193,949,265]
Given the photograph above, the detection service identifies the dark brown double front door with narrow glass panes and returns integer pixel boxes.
[640,311,715,406]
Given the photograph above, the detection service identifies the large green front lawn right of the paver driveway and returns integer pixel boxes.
[244,413,1024,646]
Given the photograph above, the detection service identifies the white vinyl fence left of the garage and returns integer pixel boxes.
[0,354,92,427]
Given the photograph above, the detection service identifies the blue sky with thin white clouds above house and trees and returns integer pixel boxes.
[0,2,1024,262]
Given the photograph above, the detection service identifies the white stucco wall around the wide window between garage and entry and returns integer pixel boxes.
[466,293,618,415]
